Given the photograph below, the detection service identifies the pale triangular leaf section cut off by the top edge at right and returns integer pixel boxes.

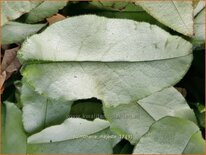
[136,0,193,37]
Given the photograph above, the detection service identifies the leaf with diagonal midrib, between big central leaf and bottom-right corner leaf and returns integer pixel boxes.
[104,87,196,144]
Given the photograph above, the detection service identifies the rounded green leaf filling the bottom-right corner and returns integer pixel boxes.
[133,117,205,154]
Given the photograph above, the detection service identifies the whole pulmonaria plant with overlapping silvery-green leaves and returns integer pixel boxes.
[2,0,205,154]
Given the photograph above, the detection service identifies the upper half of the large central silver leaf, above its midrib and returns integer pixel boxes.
[20,15,192,62]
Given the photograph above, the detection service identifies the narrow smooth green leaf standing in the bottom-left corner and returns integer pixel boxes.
[1,102,26,154]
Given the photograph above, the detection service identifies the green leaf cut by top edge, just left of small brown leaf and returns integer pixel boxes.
[22,0,67,23]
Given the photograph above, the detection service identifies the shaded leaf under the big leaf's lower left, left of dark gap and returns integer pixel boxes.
[21,83,72,133]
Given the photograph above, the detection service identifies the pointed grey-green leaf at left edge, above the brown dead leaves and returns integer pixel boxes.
[2,22,46,44]
